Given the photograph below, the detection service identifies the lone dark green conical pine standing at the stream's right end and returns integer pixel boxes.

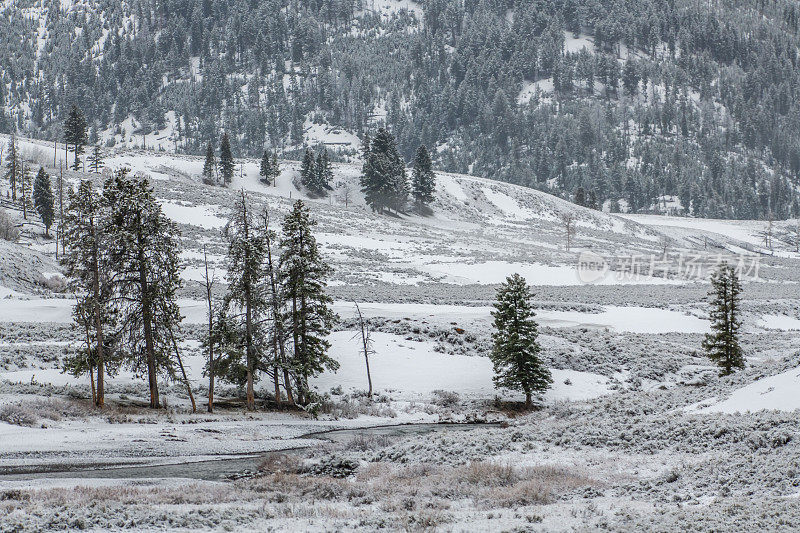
[489,274,553,408]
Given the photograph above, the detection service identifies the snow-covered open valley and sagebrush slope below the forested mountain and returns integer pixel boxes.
[0,133,800,531]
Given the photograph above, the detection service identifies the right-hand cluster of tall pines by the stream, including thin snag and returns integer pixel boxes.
[208,192,339,410]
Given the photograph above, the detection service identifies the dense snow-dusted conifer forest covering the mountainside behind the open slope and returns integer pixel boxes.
[0,0,800,219]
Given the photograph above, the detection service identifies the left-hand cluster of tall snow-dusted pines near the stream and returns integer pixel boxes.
[62,169,182,407]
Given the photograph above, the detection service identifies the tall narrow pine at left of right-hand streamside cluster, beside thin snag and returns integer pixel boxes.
[225,191,269,410]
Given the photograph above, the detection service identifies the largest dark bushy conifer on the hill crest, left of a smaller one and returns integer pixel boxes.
[361,128,408,212]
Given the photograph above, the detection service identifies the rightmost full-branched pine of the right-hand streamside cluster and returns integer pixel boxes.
[278,200,339,404]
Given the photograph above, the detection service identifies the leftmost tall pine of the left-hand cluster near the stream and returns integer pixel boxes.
[61,181,117,407]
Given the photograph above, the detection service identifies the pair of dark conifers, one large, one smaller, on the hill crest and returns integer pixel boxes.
[361,128,436,214]
